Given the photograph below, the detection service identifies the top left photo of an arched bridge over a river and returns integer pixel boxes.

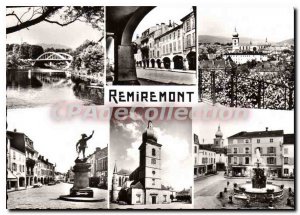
[6,6,105,108]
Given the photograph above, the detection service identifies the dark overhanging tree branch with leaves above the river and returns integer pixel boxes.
[6,6,104,34]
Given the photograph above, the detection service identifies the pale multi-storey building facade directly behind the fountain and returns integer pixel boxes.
[228,128,294,178]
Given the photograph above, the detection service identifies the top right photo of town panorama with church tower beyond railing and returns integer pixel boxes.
[197,7,295,110]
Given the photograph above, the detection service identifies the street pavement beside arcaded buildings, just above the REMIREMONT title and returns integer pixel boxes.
[136,68,197,85]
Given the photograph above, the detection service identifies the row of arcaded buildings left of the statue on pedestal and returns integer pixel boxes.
[6,130,55,191]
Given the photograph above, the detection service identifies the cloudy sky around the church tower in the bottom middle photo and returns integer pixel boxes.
[110,109,193,191]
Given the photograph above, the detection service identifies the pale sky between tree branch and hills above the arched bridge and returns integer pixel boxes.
[6,9,101,49]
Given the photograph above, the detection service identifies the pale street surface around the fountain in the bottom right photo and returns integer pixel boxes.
[194,172,294,209]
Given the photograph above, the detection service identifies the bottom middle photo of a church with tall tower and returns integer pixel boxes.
[109,107,193,209]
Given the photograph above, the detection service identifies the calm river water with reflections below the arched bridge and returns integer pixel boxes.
[6,68,104,108]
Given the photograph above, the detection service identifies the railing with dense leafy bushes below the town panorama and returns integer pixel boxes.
[199,69,294,110]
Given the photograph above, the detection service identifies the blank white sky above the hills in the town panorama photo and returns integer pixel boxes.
[197,7,294,42]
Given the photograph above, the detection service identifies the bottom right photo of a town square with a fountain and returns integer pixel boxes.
[193,109,296,210]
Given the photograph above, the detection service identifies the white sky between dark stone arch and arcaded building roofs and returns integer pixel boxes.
[132,6,193,40]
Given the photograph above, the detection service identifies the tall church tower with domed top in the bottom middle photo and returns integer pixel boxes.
[139,121,162,189]
